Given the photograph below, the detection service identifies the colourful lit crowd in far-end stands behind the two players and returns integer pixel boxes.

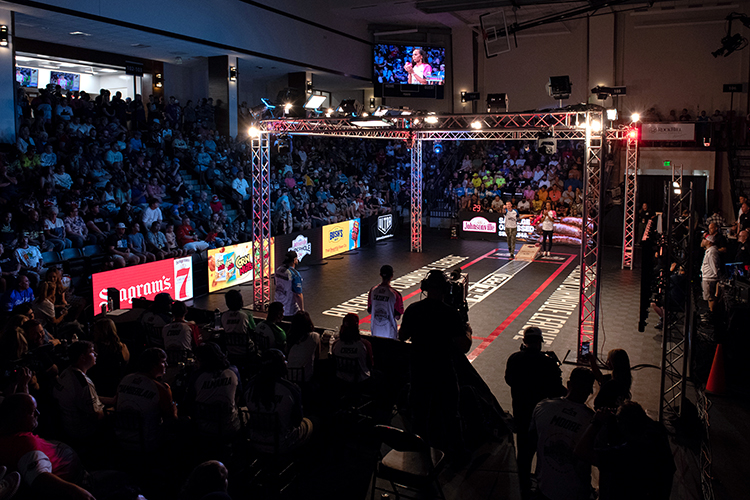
[448,141,583,216]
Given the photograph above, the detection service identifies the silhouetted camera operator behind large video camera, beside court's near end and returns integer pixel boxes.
[399,270,471,456]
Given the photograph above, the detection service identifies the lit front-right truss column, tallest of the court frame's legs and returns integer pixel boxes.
[578,112,606,363]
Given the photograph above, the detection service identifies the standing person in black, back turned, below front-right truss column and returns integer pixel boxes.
[505,326,567,498]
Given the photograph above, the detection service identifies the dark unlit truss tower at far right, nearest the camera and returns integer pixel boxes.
[659,166,693,422]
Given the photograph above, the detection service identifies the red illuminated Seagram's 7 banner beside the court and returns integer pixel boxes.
[91,257,193,311]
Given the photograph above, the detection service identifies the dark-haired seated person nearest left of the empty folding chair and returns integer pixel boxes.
[245,349,313,455]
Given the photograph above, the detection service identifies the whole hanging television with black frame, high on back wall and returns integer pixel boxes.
[373,44,446,99]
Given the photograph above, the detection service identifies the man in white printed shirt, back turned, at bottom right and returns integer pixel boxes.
[529,367,594,500]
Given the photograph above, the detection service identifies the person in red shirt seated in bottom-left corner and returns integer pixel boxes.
[0,393,94,500]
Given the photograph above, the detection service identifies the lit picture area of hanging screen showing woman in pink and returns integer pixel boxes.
[373,44,445,85]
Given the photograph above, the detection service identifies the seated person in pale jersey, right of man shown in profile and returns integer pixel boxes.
[115,347,177,451]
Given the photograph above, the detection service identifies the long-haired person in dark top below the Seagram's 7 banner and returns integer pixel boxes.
[87,318,130,397]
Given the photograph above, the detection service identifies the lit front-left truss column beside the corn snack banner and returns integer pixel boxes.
[251,133,272,311]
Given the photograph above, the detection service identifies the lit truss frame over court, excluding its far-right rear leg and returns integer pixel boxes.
[251,111,637,360]
